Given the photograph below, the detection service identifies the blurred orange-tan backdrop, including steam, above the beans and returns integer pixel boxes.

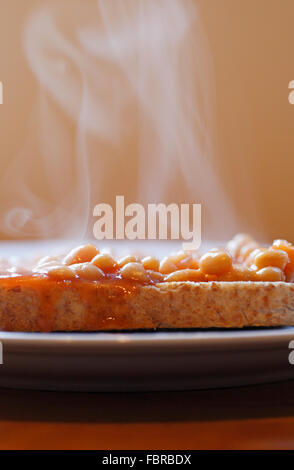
[0,0,294,241]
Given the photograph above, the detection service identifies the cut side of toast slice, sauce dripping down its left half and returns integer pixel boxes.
[0,279,294,331]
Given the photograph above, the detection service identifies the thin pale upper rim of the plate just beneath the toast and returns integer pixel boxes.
[0,326,294,350]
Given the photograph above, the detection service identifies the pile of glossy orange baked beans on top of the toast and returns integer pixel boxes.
[33,234,294,284]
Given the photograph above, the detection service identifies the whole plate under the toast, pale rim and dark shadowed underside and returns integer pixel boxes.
[0,328,294,391]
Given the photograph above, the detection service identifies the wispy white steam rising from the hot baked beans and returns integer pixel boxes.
[1,0,239,238]
